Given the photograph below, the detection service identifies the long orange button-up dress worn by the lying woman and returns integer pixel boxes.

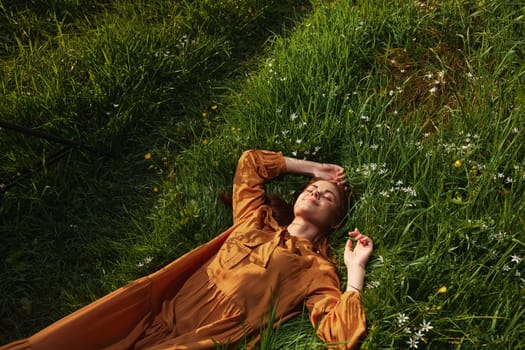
[0,150,365,350]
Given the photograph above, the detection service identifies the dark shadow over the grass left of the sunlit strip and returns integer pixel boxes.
[0,1,309,343]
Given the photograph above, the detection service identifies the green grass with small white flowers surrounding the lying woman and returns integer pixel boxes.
[0,0,525,349]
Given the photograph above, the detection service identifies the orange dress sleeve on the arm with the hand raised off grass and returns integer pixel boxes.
[306,262,366,349]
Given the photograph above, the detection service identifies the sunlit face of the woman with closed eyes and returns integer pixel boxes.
[294,180,341,230]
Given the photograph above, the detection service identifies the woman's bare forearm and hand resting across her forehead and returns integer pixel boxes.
[284,157,345,185]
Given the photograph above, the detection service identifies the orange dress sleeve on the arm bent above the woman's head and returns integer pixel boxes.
[232,150,286,223]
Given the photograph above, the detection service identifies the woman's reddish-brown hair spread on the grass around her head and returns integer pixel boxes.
[219,178,354,260]
